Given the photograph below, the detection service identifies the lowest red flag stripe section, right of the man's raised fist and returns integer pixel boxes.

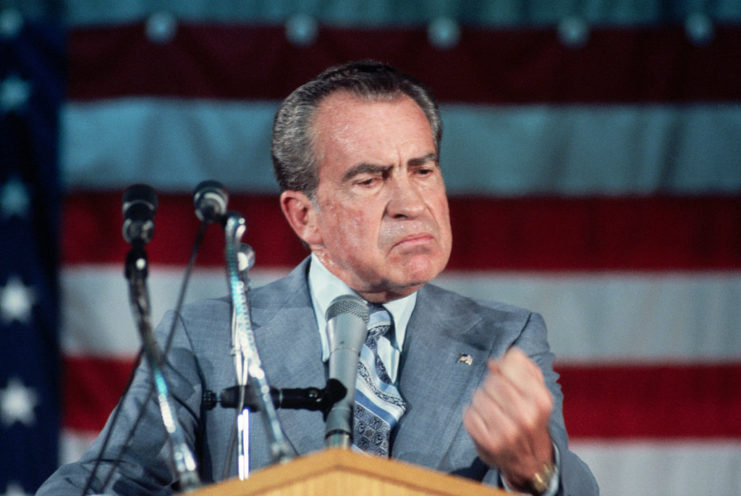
[556,362,741,438]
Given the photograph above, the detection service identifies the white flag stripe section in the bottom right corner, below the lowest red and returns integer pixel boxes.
[571,440,741,496]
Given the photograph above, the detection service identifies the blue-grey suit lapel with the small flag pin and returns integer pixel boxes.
[392,285,492,470]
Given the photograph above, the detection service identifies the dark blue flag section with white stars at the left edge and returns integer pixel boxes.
[0,12,65,495]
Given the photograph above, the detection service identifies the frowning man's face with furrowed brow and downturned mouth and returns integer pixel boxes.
[305,92,452,301]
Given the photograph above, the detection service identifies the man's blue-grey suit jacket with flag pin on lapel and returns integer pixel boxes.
[37,260,598,495]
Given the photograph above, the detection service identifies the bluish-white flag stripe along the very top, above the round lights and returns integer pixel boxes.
[62,0,741,28]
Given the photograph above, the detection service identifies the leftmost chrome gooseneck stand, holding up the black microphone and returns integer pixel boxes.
[125,240,201,491]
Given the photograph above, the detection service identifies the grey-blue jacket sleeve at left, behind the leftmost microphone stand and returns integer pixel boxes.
[36,313,201,496]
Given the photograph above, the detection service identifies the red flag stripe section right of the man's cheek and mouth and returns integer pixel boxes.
[449,197,741,270]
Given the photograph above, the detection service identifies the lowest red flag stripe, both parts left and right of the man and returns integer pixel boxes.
[64,357,741,439]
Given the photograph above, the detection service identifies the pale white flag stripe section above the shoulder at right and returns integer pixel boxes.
[438,272,741,363]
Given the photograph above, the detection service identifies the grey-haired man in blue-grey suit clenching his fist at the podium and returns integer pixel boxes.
[40,62,598,495]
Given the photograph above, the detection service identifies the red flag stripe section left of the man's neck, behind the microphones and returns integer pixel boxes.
[62,192,307,267]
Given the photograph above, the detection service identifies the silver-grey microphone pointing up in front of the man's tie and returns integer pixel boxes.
[324,295,368,448]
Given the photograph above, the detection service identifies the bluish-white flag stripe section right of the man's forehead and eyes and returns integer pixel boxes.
[442,105,741,195]
